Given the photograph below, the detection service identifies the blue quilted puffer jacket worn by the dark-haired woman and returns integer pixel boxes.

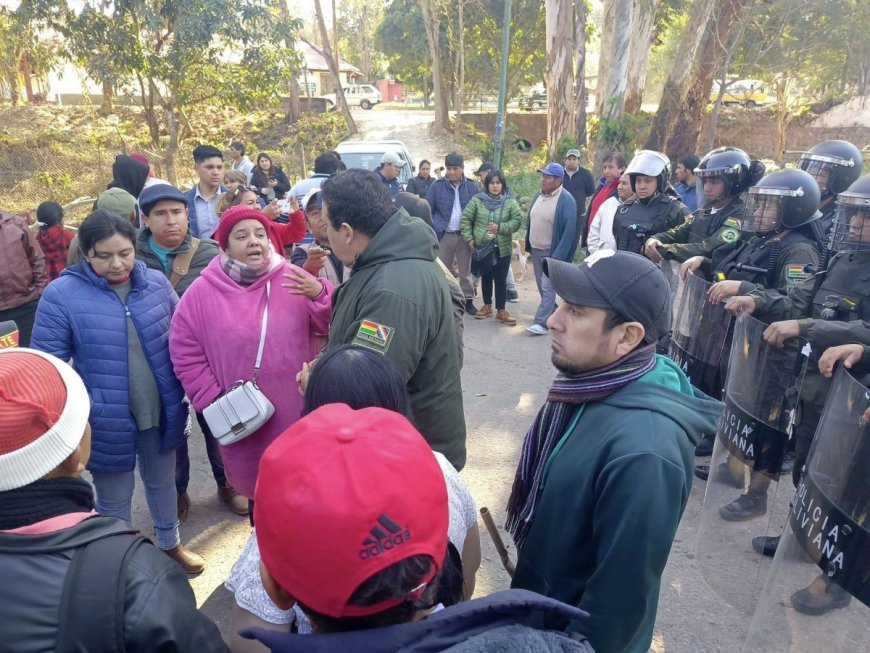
[31,261,187,472]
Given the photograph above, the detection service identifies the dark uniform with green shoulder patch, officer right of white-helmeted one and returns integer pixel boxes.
[653,197,744,263]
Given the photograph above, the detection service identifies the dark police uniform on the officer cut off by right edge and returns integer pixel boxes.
[749,247,870,484]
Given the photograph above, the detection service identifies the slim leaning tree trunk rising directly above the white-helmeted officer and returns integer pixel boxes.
[644,0,715,150]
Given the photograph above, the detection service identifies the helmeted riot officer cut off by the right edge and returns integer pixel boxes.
[727,175,870,576]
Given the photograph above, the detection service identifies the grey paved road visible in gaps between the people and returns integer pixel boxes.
[124,110,748,653]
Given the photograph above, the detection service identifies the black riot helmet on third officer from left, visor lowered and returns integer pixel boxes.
[743,168,822,234]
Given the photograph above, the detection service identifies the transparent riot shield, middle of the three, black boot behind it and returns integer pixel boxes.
[696,314,810,615]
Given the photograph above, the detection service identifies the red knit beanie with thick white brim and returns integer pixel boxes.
[0,349,90,492]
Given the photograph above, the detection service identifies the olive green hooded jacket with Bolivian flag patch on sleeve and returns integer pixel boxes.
[327,210,465,470]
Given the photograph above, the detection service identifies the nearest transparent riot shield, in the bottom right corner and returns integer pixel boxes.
[743,368,870,653]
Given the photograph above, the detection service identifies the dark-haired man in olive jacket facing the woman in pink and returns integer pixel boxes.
[322,170,465,469]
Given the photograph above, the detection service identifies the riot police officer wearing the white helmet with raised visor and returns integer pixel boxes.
[613,150,689,254]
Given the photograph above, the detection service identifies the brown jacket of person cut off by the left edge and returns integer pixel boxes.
[0,211,48,311]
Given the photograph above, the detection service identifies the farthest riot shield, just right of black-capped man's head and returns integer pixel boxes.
[668,274,731,399]
